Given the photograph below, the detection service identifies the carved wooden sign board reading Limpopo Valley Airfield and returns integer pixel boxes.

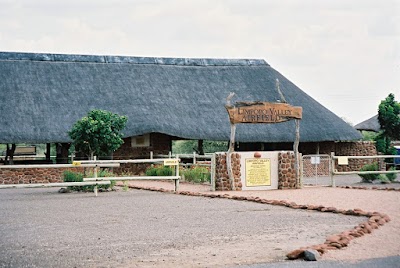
[225,102,303,124]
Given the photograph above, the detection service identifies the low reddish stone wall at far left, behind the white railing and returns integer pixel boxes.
[0,168,84,184]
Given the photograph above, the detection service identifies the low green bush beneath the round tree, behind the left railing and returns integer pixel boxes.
[63,169,115,192]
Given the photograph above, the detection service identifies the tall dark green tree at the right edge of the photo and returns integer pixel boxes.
[375,93,400,155]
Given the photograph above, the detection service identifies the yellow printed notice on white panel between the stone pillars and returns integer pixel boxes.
[245,158,271,187]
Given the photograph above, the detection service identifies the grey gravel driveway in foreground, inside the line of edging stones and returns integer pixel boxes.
[0,188,365,267]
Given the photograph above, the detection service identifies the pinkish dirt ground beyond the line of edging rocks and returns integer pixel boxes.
[126,176,400,262]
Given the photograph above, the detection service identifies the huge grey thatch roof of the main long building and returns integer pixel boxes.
[0,52,361,143]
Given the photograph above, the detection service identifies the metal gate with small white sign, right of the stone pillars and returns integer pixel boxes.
[302,154,332,185]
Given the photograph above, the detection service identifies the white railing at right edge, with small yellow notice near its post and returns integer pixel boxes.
[331,152,400,187]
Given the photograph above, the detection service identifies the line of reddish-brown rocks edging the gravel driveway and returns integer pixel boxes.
[129,185,391,260]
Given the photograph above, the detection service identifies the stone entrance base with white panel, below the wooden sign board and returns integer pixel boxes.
[215,151,299,191]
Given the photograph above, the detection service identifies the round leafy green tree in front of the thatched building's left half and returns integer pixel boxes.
[68,110,128,159]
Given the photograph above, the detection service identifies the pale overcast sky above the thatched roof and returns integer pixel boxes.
[0,0,400,125]
